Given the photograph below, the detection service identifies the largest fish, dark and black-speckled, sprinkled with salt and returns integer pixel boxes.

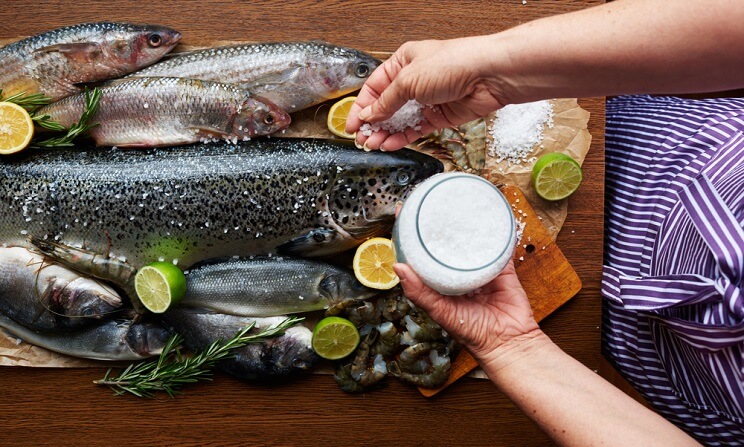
[0,138,443,268]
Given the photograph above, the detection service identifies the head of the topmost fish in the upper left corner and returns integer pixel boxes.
[100,25,181,75]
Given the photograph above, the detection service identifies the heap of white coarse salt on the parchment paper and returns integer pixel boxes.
[489,100,553,164]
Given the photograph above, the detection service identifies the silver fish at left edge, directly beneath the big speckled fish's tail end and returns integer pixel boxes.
[0,247,122,332]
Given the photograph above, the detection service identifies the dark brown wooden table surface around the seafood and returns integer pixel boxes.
[0,0,604,447]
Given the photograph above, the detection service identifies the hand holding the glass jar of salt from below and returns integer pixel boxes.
[393,261,541,363]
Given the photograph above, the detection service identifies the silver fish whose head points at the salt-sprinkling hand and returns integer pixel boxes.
[125,42,381,112]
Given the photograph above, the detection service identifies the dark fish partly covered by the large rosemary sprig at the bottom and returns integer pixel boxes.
[163,312,320,380]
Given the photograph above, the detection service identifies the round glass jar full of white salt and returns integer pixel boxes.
[393,173,517,295]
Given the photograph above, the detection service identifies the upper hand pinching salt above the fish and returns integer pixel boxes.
[346,36,505,150]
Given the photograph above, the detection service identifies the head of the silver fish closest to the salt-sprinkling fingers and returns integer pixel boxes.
[307,46,382,98]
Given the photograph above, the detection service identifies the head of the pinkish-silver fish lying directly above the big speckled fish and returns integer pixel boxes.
[232,97,292,139]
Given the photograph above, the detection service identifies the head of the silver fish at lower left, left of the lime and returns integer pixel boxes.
[49,276,122,319]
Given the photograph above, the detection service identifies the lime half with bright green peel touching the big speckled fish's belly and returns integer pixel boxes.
[134,262,186,314]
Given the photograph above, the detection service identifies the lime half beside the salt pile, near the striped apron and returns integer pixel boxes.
[532,152,583,201]
